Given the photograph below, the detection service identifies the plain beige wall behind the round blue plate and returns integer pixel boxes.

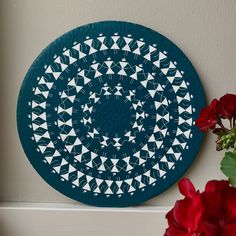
[0,0,236,206]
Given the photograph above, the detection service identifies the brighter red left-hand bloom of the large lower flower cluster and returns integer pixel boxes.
[165,179,205,236]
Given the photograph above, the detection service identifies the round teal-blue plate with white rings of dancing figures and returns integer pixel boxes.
[17,21,205,206]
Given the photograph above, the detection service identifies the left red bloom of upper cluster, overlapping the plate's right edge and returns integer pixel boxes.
[196,99,219,131]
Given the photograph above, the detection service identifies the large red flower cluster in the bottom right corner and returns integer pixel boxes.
[165,179,236,236]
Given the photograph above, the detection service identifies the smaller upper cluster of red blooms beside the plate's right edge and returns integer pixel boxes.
[196,94,236,131]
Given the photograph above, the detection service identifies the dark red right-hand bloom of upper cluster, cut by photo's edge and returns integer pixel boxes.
[219,93,236,119]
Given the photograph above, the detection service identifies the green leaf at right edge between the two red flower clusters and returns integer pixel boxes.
[221,152,236,187]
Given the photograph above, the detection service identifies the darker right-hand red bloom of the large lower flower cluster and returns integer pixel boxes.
[201,180,236,236]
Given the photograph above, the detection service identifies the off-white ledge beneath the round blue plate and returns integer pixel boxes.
[0,202,170,236]
